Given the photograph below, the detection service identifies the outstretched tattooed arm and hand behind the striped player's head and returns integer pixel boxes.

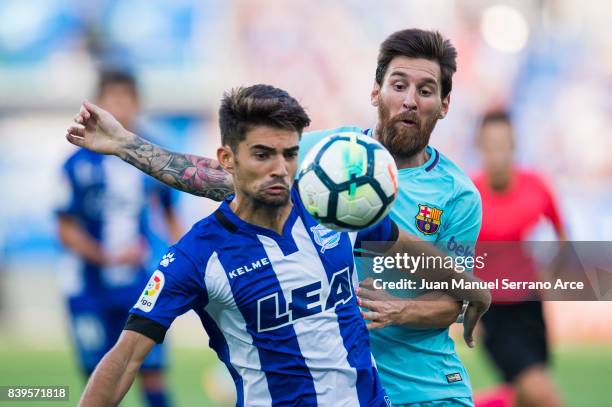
[66,101,234,201]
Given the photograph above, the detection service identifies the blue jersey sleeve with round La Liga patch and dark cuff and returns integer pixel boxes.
[124,245,205,343]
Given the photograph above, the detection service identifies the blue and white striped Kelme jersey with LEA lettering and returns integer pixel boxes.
[126,188,398,407]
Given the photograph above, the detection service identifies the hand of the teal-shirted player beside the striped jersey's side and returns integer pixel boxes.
[355,278,406,330]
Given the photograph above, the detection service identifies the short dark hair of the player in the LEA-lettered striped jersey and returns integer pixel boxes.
[219,84,310,151]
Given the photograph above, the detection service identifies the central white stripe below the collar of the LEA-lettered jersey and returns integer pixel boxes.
[256,218,359,406]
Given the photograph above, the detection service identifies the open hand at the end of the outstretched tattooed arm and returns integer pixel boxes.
[66,101,134,155]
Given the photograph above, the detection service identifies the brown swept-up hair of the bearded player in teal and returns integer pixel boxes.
[376,28,457,99]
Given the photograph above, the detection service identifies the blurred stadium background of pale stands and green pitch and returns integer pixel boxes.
[0,0,612,406]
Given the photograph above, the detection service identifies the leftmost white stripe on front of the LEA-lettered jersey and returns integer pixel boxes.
[204,252,272,407]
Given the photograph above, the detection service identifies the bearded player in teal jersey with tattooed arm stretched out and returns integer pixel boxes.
[67,29,482,406]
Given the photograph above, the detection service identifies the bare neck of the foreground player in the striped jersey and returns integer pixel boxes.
[230,195,293,235]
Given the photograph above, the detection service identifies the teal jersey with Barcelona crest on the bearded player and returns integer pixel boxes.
[299,126,482,405]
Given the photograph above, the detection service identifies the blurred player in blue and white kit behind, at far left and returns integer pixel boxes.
[56,71,182,407]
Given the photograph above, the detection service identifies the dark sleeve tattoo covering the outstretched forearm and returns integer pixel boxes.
[120,137,234,201]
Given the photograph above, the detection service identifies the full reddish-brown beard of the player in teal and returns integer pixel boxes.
[376,99,440,158]
